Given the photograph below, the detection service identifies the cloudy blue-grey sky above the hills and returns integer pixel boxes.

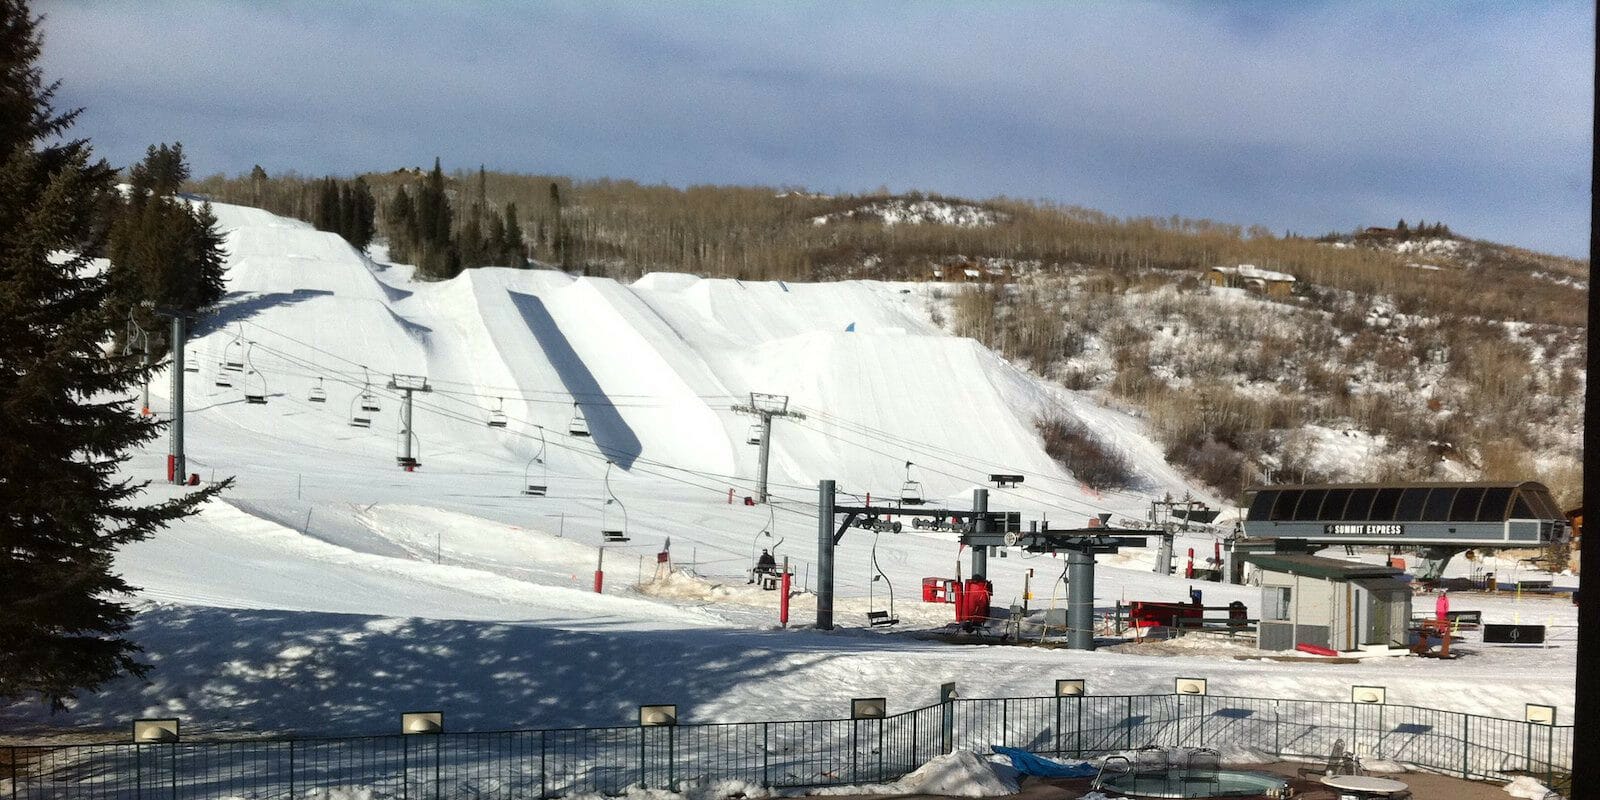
[35,0,1595,254]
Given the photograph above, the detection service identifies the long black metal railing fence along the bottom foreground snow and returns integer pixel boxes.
[0,694,1573,800]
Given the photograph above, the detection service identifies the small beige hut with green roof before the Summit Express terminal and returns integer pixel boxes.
[1245,552,1411,651]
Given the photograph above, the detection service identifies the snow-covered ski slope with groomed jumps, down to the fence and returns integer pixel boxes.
[0,205,1573,733]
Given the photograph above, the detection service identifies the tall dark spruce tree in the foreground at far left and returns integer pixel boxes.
[0,0,225,709]
